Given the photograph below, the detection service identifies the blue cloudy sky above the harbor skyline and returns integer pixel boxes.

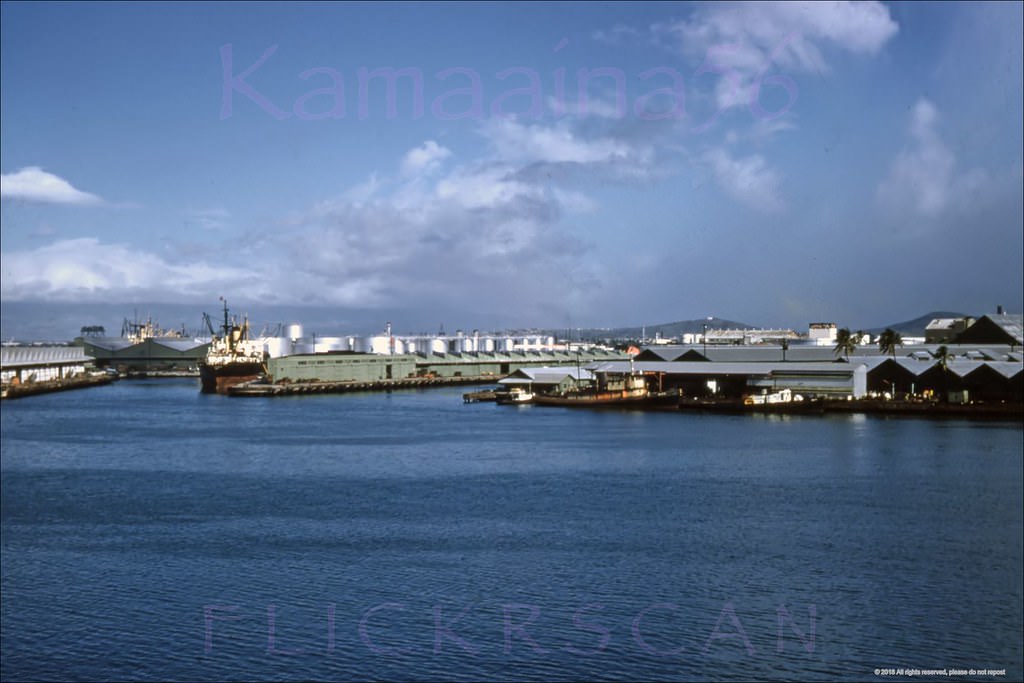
[0,1,1024,339]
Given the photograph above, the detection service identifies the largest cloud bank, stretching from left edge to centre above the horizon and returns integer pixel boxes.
[2,120,655,319]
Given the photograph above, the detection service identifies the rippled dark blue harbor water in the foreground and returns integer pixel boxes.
[0,380,1024,681]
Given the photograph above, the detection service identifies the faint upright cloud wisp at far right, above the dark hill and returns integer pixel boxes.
[878,98,987,218]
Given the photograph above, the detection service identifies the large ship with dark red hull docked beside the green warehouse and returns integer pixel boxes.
[199,297,266,393]
